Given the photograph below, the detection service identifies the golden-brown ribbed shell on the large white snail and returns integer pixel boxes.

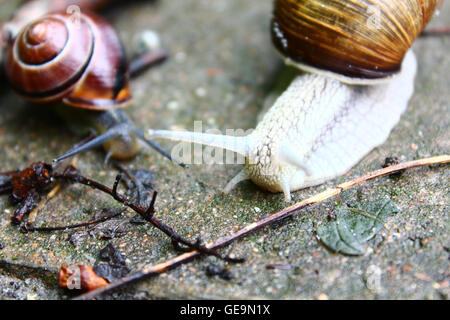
[272,0,442,79]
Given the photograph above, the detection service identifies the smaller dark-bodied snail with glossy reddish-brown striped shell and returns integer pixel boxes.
[4,0,178,165]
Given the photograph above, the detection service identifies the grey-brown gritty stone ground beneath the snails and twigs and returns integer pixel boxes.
[0,0,450,299]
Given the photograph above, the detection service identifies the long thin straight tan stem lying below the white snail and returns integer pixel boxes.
[75,155,450,300]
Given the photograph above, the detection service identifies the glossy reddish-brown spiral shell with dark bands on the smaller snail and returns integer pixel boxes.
[5,12,131,110]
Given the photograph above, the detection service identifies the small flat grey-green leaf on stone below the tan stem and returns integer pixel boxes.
[317,199,398,255]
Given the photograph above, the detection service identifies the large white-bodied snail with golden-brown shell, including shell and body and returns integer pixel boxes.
[147,0,441,201]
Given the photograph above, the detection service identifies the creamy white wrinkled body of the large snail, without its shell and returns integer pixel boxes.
[148,52,416,201]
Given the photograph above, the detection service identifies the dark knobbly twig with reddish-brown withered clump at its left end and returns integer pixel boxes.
[0,162,244,263]
